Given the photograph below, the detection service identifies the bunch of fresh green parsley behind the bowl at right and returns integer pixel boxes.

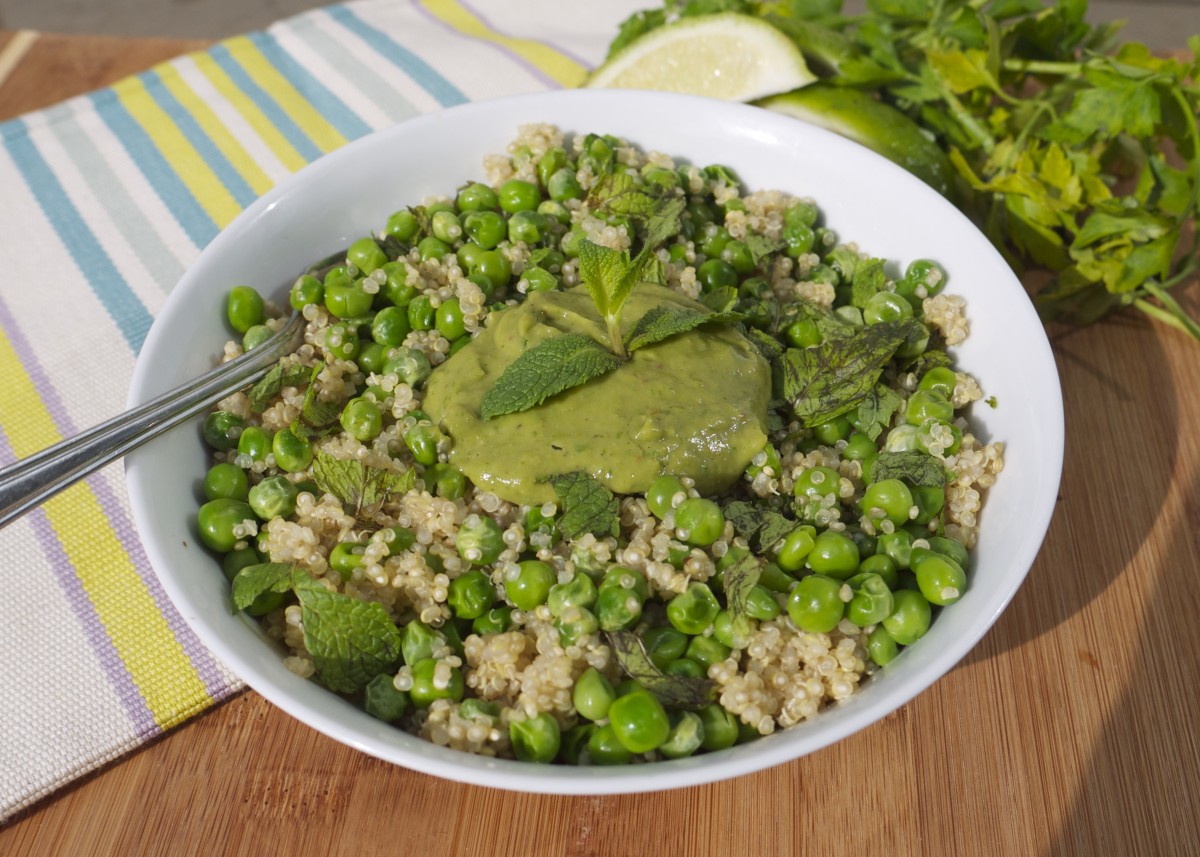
[612,0,1200,341]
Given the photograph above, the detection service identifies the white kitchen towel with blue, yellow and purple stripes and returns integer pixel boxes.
[0,0,643,821]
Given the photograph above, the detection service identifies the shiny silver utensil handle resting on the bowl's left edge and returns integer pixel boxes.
[0,313,304,528]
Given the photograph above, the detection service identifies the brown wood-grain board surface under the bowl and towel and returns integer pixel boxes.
[0,34,1200,857]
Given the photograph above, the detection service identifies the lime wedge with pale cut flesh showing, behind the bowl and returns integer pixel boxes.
[583,12,815,101]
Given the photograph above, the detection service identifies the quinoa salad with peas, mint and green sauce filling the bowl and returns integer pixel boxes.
[196,125,1003,765]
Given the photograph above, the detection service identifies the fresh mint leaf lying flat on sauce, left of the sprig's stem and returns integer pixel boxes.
[480,334,622,420]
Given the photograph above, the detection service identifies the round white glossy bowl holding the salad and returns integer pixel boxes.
[126,90,1063,795]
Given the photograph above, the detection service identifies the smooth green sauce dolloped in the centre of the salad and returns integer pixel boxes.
[424,283,770,505]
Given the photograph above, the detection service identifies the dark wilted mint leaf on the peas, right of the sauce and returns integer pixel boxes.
[773,318,920,427]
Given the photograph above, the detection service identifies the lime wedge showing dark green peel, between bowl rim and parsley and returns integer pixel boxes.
[755,84,953,196]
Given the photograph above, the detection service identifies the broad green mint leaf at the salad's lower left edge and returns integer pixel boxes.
[295,575,401,694]
